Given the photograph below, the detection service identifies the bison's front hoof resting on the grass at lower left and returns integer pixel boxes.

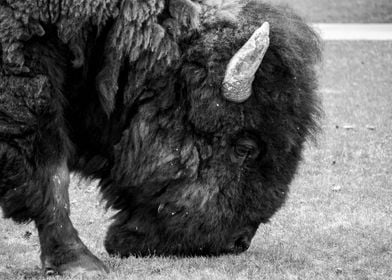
[43,251,109,277]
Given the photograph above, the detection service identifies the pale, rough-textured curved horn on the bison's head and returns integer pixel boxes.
[222,22,269,103]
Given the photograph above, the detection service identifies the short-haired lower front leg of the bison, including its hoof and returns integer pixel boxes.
[35,162,107,275]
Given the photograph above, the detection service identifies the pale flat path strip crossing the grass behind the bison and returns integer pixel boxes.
[312,23,392,41]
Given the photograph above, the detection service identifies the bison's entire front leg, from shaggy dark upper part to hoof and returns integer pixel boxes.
[0,74,107,274]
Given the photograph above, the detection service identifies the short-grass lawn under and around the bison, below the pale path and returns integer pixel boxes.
[0,1,392,280]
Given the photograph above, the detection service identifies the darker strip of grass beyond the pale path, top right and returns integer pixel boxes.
[266,0,392,23]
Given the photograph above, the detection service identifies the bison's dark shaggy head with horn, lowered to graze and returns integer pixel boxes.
[102,3,320,256]
